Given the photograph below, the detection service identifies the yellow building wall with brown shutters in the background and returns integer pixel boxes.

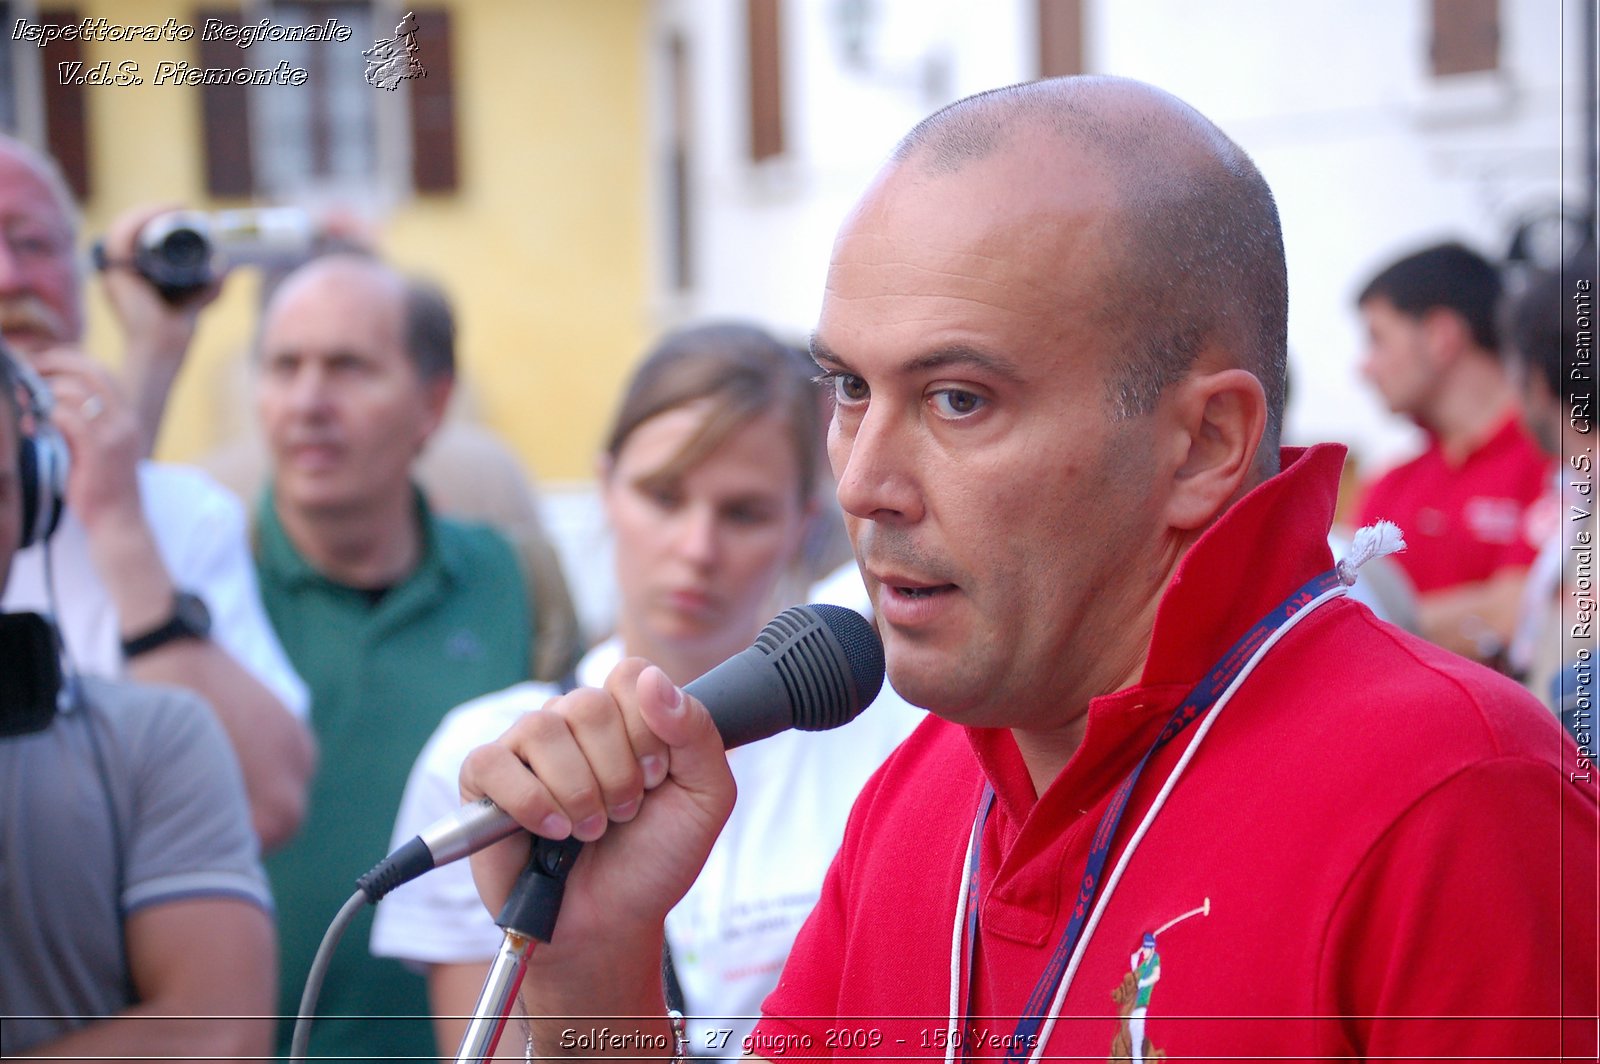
[58,0,651,480]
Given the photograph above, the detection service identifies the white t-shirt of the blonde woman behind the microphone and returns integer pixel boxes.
[371,578,923,1058]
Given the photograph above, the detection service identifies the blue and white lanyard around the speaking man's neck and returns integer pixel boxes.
[944,563,1356,1064]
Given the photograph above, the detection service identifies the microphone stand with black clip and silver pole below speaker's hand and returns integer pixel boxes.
[456,835,582,1064]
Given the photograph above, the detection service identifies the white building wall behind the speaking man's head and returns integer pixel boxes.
[646,0,1584,466]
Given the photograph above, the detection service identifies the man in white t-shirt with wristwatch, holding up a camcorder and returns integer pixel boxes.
[0,136,314,848]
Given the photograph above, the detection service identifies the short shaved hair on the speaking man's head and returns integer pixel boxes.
[891,77,1288,472]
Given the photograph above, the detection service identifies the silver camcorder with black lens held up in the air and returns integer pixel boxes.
[94,206,317,306]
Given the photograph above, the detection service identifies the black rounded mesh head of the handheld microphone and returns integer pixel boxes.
[755,602,883,731]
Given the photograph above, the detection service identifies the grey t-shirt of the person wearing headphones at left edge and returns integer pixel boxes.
[0,678,272,1054]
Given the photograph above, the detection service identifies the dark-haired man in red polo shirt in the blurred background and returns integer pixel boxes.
[1357,243,1549,662]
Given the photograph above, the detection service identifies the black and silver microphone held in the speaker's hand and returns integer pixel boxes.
[357,603,883,902]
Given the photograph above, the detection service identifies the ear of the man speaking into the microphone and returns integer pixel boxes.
[1166,368,1267,531]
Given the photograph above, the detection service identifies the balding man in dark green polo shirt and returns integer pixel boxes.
[254,256,531,1059]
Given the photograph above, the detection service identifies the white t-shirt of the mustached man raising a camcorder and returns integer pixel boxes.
[0,462,310,718]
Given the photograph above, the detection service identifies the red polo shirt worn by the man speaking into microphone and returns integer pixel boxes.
[750,446,1600,1059]
